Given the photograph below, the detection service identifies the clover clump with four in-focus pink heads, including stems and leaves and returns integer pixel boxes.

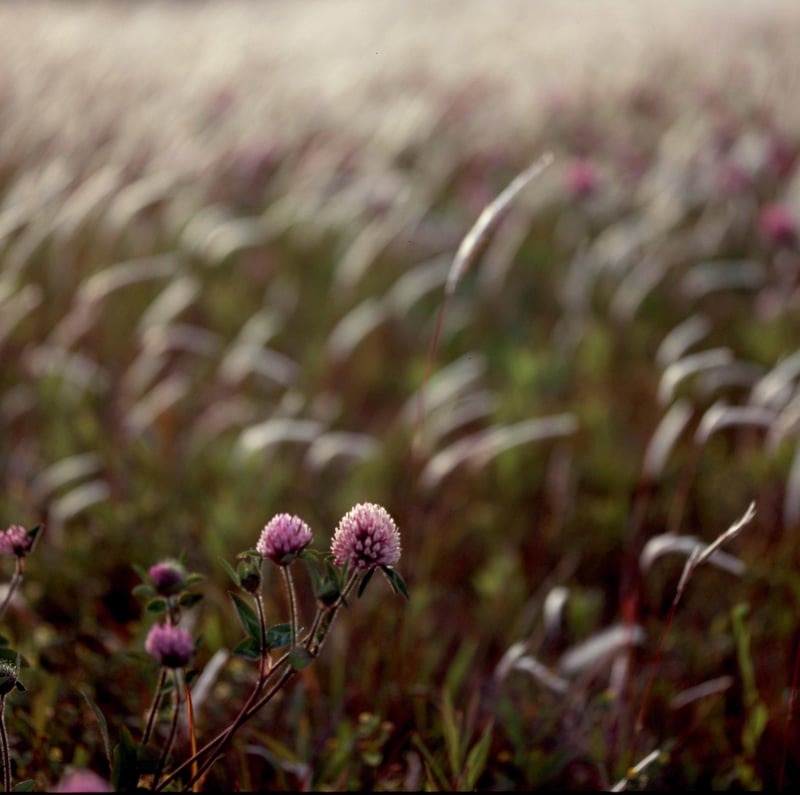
[111,503,408,791]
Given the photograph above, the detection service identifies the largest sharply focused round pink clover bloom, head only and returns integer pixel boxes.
[331,502,400,570]
